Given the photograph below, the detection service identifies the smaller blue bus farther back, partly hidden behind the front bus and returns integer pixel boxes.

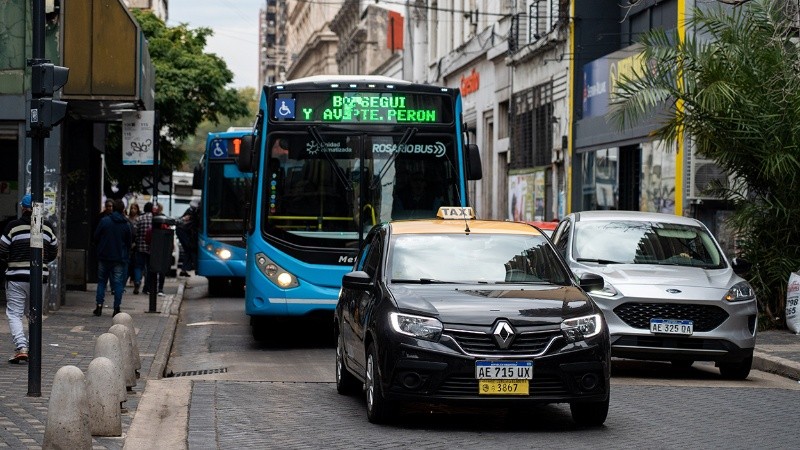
[193,128,253,295]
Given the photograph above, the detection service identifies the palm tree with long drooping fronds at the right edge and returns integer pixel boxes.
[609,0,800,326]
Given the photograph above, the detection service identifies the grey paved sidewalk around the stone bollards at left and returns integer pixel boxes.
[0,278,184,449]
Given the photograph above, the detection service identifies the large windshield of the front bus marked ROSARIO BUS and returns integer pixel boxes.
[262,128,460,249]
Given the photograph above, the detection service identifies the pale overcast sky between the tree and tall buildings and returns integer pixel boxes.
[167,0,267,88]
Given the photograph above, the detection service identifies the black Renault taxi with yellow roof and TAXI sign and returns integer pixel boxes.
[335,207,610,426]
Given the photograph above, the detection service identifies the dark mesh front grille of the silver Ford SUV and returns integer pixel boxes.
[614,303,728,331]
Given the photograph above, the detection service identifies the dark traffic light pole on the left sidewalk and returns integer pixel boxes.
[28,0,68,397]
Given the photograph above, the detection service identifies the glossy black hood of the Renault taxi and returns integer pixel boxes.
[392,284,596,325]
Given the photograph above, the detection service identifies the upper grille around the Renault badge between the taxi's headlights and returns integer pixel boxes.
[443,329,563,355]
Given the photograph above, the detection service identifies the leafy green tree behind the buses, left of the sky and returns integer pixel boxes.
[106,9,249,192]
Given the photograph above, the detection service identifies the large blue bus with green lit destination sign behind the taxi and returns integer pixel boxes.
[238,76,481,339]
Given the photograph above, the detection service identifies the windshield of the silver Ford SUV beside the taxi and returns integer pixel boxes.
[573,220,725,269]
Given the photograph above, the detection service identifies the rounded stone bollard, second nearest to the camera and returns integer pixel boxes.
[86,356,122,436]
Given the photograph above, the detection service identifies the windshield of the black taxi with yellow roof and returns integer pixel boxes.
[389,233,571,285]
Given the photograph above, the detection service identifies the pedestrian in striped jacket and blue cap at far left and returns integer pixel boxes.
[0,194,58,364]
